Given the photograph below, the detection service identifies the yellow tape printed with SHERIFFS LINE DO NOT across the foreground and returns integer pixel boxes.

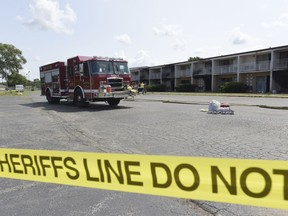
[0,148,288,209]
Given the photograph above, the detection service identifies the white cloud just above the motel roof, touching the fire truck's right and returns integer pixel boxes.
[129,50,158,67]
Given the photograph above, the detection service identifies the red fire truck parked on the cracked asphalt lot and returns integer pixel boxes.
[40,56,131,107]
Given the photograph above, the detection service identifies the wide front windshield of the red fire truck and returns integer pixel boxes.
[90,61,129,74]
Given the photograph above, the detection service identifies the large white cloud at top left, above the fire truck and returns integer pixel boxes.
[17,0,77,34]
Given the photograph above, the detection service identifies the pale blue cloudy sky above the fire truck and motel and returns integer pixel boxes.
[0,0,288,80]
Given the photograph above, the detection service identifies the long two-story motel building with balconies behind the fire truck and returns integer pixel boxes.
[130,45,288,93]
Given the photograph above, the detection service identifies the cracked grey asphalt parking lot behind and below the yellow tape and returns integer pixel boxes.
[0,92,288,215]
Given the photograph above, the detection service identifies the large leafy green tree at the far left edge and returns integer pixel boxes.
[0,43,27,85]
